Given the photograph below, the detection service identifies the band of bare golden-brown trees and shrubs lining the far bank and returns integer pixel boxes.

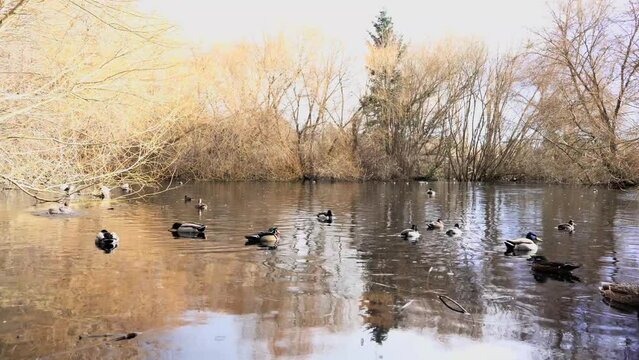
[0,0,639,200]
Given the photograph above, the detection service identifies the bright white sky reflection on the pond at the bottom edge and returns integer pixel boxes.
[156,312,548,360]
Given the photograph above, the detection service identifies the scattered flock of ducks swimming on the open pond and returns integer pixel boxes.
[82,189,639,306]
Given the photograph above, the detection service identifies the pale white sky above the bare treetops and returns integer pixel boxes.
[139,0,552,52]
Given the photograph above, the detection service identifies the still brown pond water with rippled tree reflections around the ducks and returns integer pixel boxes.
[0,182,639,360]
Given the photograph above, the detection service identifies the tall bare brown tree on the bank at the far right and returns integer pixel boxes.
[538,0,639,186]
